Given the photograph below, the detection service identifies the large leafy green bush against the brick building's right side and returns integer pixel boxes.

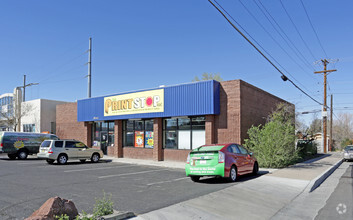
[245,104,299,168]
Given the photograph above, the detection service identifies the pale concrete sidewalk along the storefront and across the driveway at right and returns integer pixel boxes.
[109,153,342,220]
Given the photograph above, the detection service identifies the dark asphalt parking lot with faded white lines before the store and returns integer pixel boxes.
[0,154,253,219]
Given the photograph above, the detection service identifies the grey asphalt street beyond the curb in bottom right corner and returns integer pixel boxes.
[315,162,353,220]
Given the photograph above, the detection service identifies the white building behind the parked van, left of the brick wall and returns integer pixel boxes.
[21,99,67,134]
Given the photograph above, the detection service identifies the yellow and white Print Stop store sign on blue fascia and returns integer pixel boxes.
[104,89,164,116]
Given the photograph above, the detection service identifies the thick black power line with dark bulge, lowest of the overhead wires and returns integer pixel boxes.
[208,0,322,105]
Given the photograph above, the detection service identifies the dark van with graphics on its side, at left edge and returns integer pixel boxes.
[0,131,59,160]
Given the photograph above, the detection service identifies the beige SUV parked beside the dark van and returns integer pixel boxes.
[37,140,103,164]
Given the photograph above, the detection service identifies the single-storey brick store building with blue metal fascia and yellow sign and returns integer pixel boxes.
[56,80,292,161]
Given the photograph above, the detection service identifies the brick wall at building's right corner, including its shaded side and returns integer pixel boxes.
[212,80,292,144]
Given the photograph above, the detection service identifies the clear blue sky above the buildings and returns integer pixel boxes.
[0,0,353,125]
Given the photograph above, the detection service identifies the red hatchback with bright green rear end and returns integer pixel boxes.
[185,143,259,182]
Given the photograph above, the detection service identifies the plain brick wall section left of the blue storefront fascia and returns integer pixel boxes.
[56,102,91,147]
